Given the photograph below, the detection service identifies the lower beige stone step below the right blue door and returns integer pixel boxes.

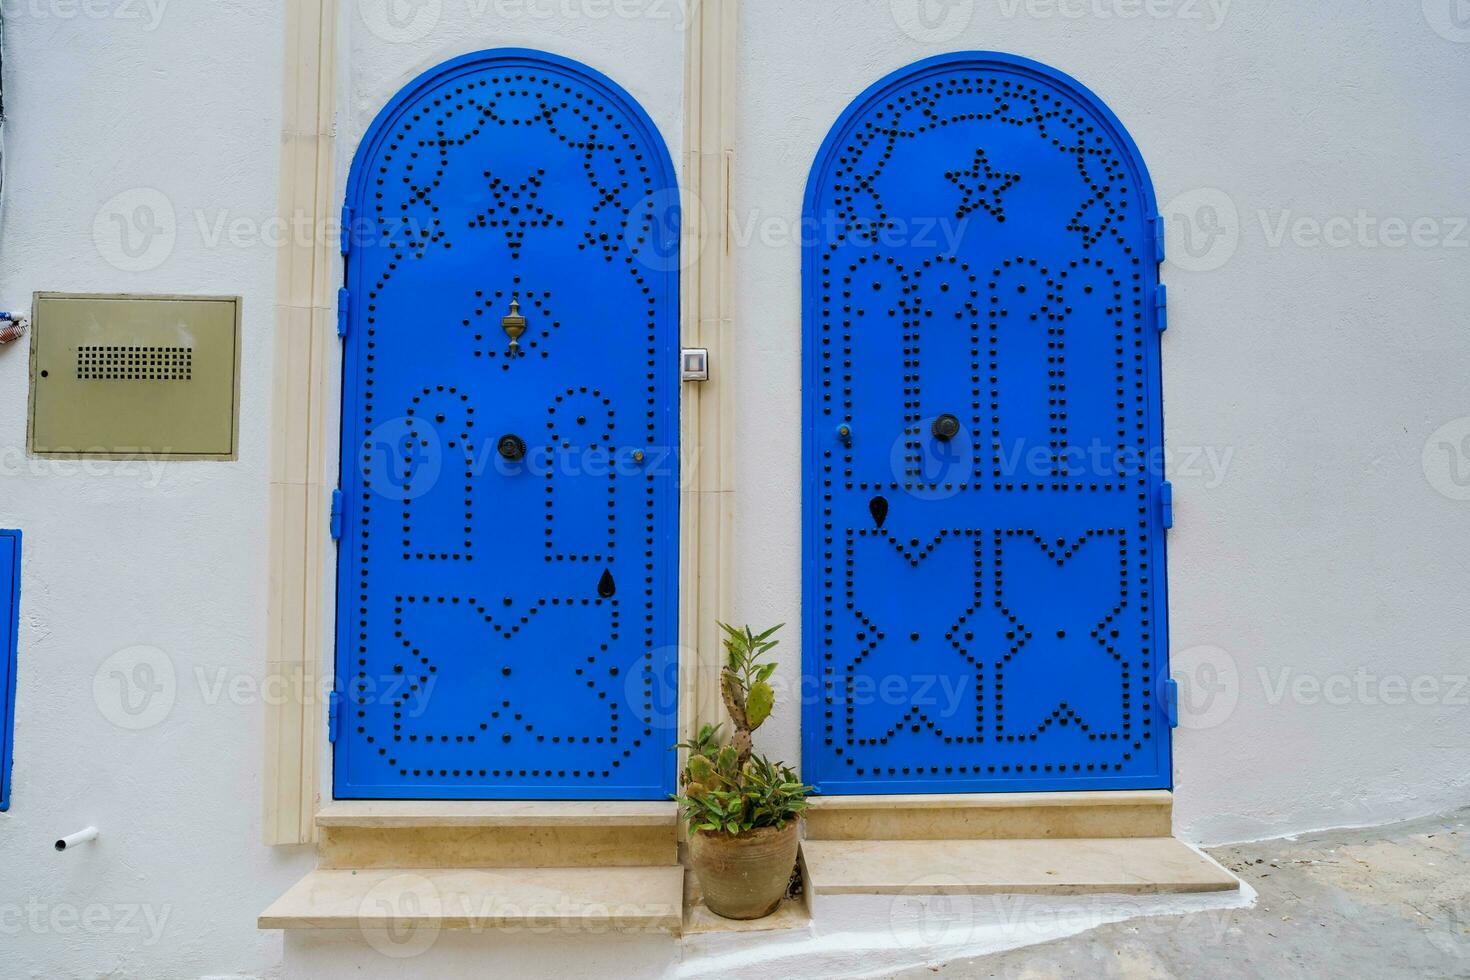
[801,837,1239,914]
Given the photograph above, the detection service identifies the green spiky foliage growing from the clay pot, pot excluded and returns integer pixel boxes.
[675,623,811,835]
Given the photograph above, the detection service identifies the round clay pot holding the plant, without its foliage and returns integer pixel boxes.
[689,820,798,918]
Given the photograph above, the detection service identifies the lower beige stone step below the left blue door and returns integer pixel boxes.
[257,865,684,942]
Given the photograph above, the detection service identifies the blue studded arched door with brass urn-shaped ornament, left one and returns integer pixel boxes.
[331,50,678,799]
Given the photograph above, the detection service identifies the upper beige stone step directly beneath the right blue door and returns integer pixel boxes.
[806,789,1173,840]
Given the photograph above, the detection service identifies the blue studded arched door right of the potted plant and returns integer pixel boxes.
[803,53,1170,793]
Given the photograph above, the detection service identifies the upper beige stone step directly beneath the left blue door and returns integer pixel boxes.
[316,801,679,870]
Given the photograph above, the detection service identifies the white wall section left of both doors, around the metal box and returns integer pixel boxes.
[0,0,312,977]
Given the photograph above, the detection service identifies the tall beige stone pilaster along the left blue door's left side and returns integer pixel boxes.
[262,0,341,843]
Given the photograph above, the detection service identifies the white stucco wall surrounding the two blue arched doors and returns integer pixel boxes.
[0,0,1470,977]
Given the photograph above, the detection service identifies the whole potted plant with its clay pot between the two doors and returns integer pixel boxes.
[675,623,811,918]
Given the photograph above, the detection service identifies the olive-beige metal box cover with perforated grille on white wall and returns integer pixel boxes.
[28,292,240,460]
